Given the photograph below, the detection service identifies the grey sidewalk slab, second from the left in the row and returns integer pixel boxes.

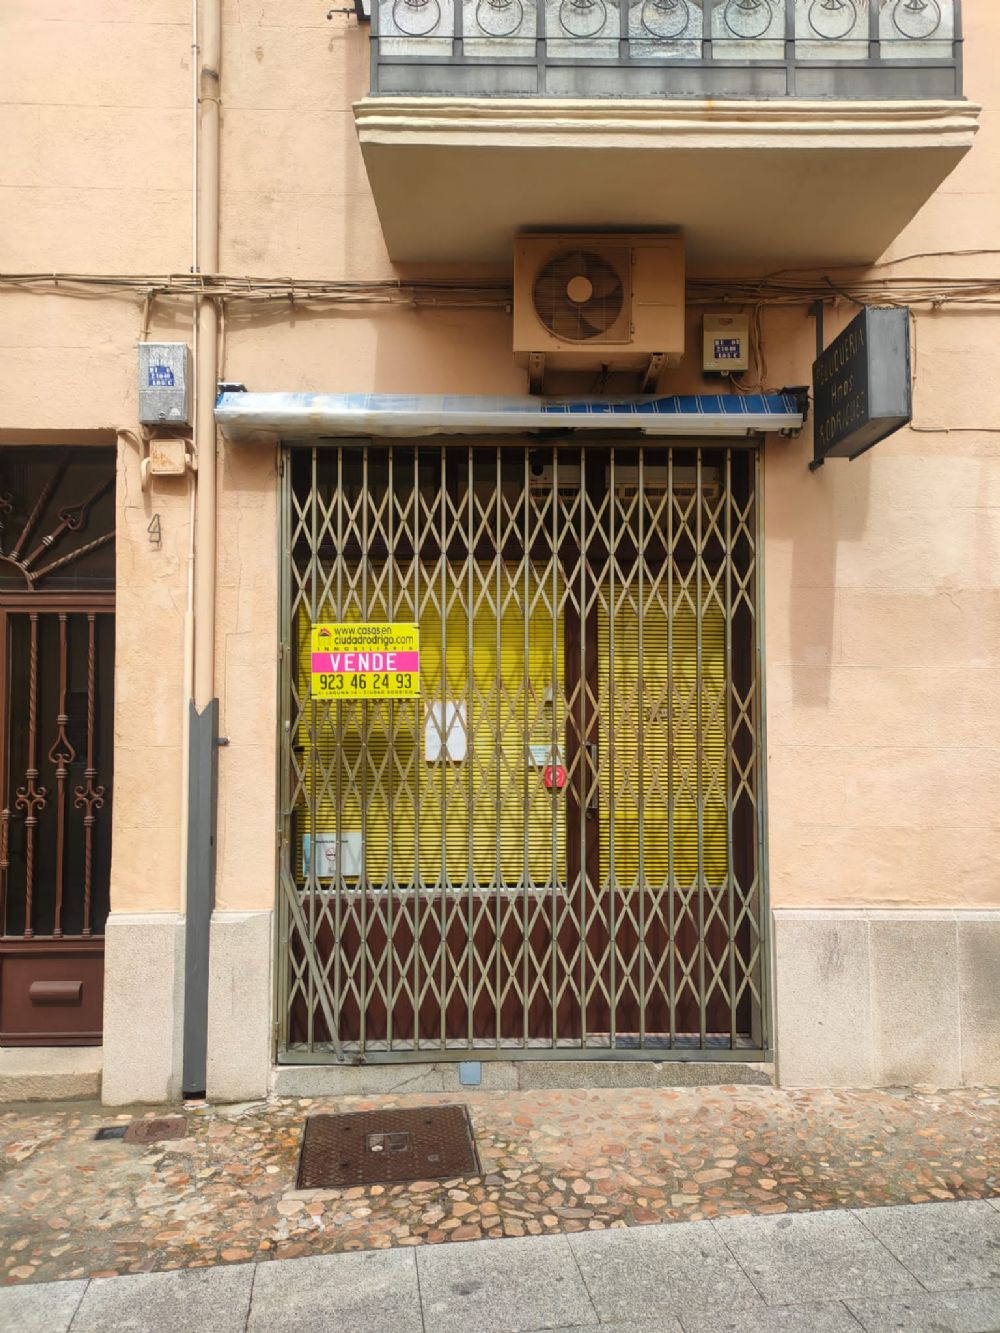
[72,1264,253,1333]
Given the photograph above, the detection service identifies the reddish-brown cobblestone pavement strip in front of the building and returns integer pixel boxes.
[0,1086,1000,1285]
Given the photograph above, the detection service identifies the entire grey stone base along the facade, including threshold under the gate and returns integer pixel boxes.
[98,909,1000,1105]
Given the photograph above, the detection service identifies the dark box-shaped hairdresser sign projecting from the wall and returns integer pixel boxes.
[812,305,912,461]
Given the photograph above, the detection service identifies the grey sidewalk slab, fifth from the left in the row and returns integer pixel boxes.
[568,1222,760,1324]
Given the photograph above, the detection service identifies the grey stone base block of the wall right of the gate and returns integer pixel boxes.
[773,909,1000,1088]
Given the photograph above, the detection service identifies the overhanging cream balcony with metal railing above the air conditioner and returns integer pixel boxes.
[355,0,979,267]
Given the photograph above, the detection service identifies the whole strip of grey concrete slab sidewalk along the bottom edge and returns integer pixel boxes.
[0,1200,1000,1333]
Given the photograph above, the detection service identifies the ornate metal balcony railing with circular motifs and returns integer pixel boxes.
[372,0,961,99]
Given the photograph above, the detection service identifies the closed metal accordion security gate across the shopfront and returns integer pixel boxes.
[277,439,769,1062]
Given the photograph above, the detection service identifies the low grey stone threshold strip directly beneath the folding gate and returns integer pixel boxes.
[271,1060,773,1097]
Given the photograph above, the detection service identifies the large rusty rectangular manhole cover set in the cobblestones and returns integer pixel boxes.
[295,1106,480,1189]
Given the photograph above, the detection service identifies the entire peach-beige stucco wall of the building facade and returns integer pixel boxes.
[0,0,1000,981]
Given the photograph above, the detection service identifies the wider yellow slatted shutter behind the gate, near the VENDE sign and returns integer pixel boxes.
[296,567,565,888]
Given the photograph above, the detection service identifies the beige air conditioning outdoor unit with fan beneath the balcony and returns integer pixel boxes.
[513,233,684,373]
